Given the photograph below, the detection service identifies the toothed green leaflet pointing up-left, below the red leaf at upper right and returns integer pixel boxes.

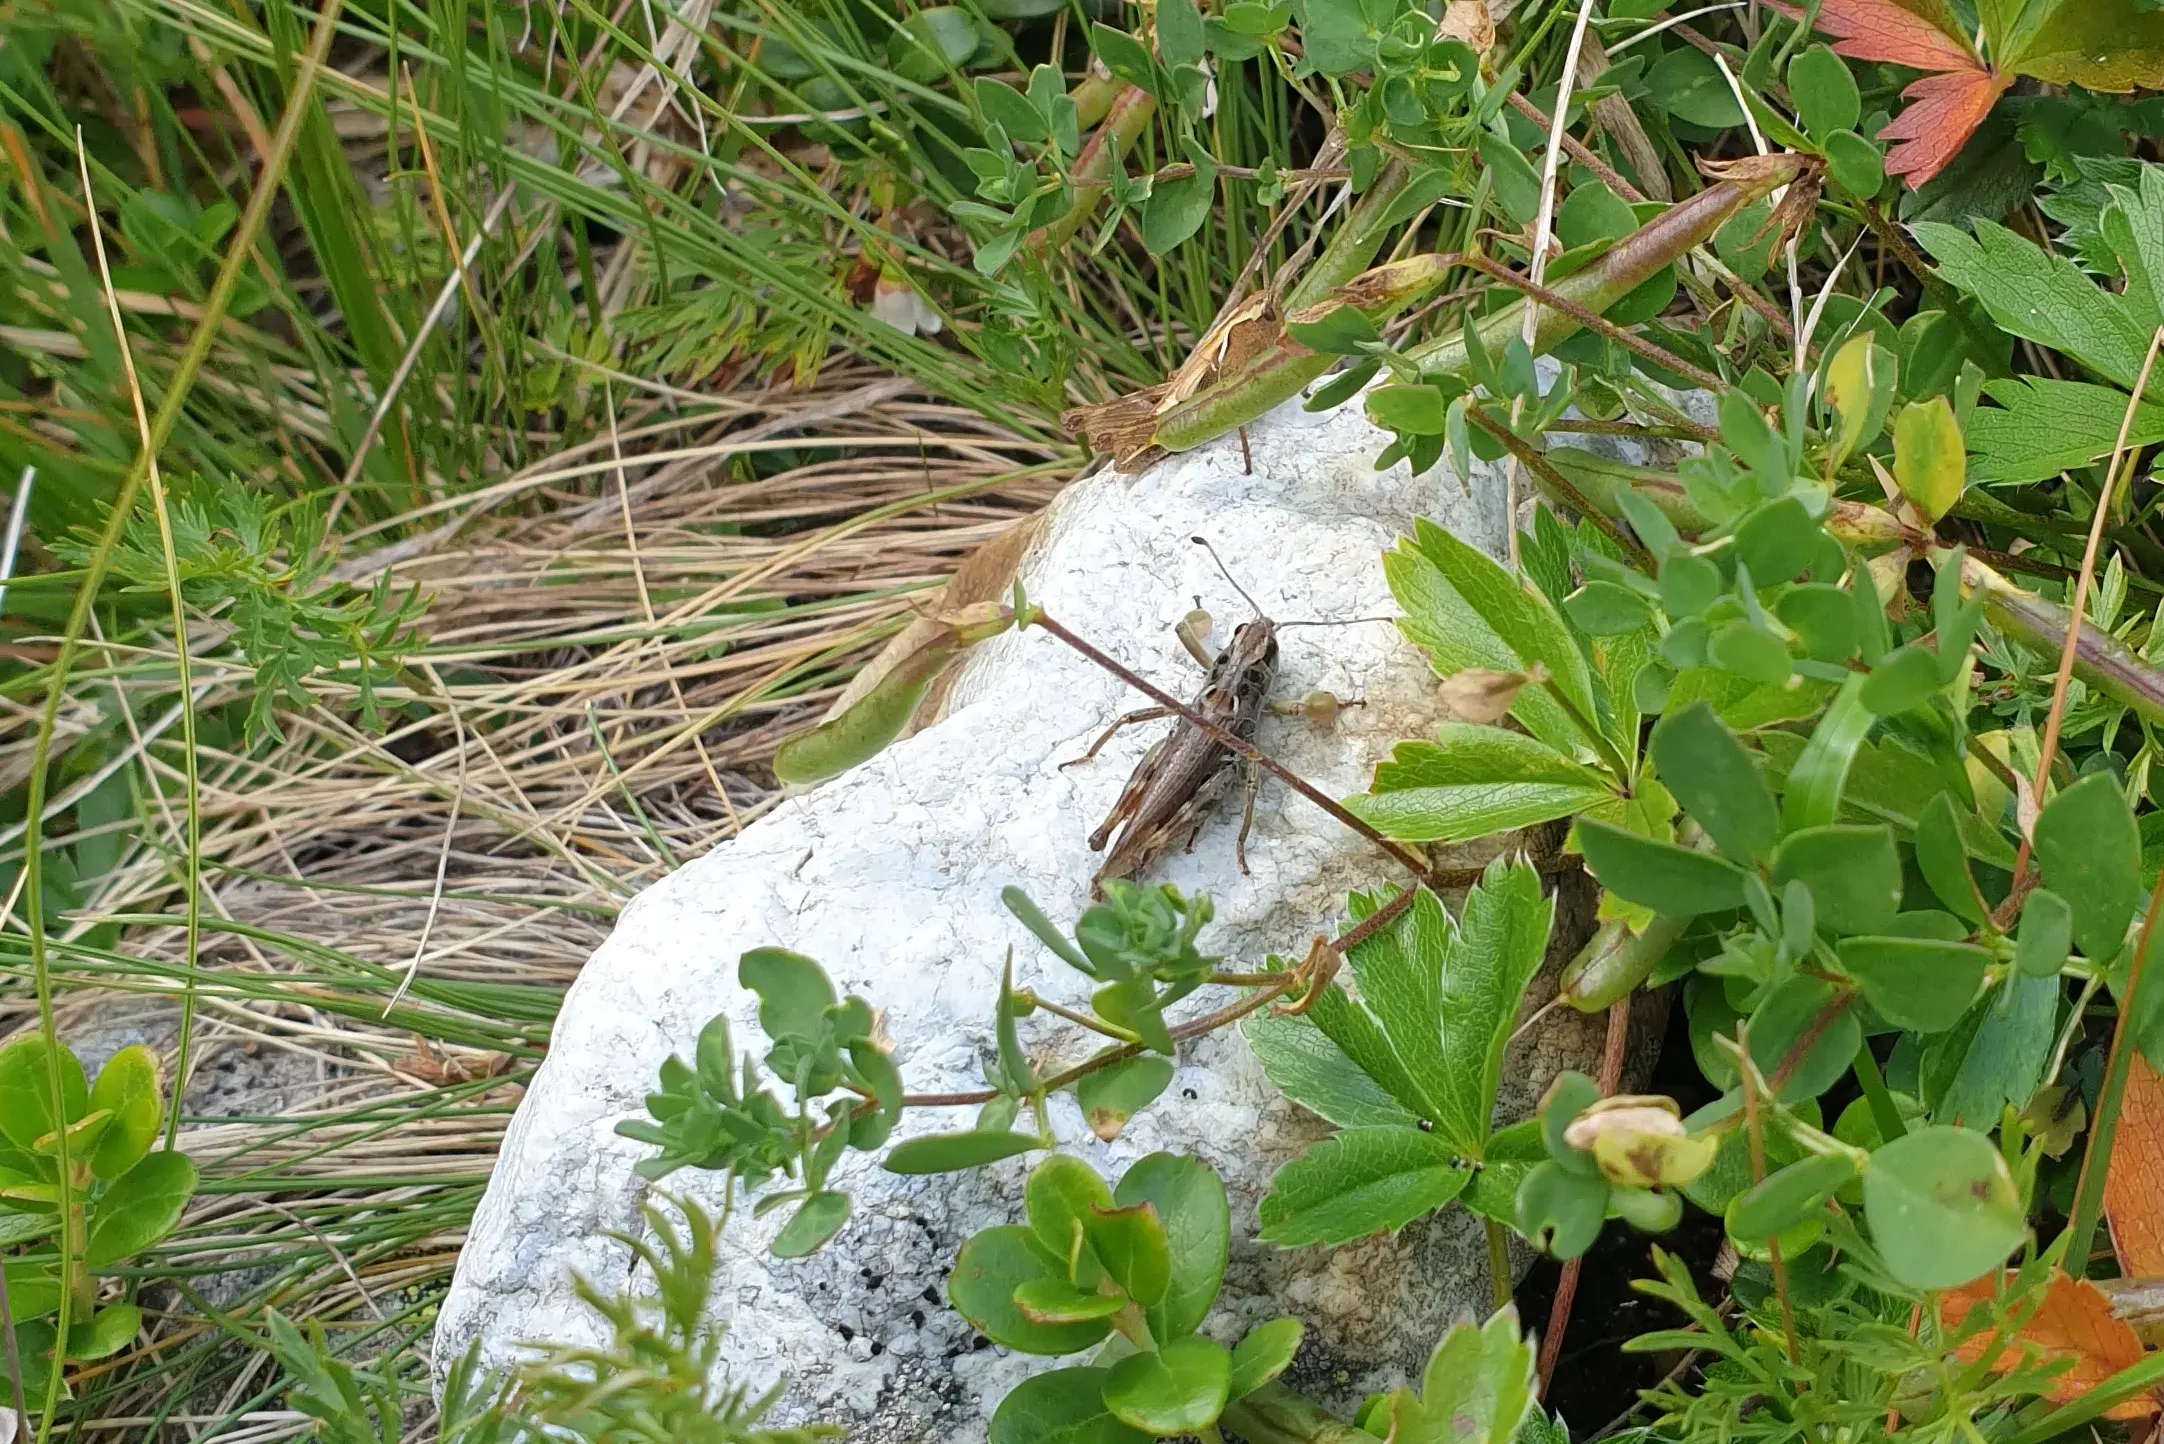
[1909,219,2149,390]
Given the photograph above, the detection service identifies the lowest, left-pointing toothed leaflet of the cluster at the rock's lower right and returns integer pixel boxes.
[1259,1128,1472,1249]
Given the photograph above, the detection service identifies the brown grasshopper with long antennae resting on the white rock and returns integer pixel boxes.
[1063,537,1350,896]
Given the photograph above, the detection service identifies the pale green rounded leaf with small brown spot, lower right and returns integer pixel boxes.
[1863,1126,2028,1288]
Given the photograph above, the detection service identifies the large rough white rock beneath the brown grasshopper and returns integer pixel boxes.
[437,387,1687,1444]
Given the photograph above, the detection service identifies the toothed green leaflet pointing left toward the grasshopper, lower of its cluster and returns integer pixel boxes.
[1344,723,1612,842]
